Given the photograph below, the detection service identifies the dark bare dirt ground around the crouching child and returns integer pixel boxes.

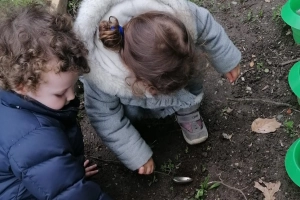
[80,0,300,200]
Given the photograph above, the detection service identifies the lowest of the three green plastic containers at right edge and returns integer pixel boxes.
[285,139,300,187]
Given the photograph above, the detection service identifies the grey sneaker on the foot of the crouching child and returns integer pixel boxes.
[176,111,208,145]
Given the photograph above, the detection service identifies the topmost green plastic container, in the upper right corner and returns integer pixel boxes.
[281,0,300,44]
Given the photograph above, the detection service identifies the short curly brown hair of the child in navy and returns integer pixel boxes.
[0,4,90,91]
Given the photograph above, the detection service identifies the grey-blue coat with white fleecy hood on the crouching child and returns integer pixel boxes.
[74,0,241,170]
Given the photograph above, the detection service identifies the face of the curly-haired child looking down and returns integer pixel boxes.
[22,71,78,110]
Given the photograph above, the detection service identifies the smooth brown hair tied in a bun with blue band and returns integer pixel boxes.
[99,12,207,94]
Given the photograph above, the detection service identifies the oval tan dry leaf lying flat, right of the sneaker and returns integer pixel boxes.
[251,118,281,133]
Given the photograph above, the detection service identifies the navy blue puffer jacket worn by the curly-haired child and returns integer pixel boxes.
[0,90,110,200]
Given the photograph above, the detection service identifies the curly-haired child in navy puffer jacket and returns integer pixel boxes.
[0,4,110,200]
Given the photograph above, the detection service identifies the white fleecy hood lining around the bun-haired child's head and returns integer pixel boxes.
[74,0,197,97]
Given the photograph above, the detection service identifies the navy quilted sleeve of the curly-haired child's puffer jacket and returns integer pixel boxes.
[8,127,110,200]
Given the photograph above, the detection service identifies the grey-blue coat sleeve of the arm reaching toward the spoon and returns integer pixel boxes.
[83,80,152,170]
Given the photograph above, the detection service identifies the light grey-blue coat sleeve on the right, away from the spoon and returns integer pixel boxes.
[189,2,241,74]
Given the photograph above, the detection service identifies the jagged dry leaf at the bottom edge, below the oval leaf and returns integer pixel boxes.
[254,180,281,200]
